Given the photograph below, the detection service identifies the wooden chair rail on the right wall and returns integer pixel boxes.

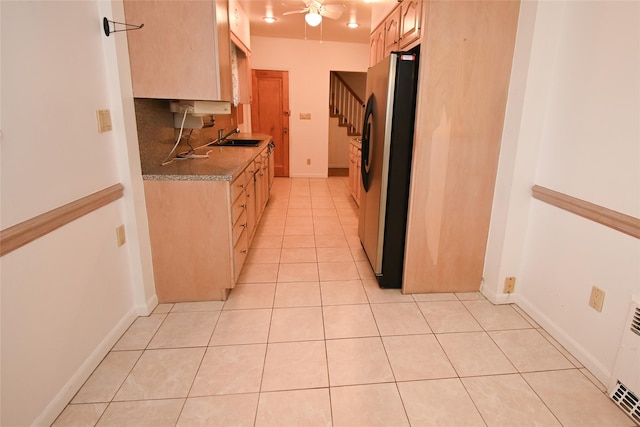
[531,185,640,239]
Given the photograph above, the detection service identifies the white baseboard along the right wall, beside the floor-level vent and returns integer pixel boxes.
[513,294,612,385]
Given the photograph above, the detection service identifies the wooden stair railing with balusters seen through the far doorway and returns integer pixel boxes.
[329,71,365,136]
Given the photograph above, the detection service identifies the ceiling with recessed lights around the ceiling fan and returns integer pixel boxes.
[239,0,371,43]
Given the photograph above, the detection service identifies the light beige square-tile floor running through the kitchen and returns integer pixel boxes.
[55,177,634,427]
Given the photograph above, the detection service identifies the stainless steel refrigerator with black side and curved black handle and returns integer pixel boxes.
[358,50,418,288]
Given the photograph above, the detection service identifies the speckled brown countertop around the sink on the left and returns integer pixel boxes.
[142,133,272,181]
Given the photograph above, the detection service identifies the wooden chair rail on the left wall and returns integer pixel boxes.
[0,184,124,256]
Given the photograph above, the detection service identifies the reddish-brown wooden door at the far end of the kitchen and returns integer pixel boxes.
[251,70,290,176]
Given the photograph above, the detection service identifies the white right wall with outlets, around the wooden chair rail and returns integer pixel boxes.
[483,1,640,393]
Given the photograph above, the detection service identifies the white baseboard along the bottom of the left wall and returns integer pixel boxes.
[33,310,139,426]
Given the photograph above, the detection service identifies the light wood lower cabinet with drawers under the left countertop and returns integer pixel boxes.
[144,147,269,303]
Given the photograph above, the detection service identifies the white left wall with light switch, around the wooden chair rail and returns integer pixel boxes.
[0,1,155,426]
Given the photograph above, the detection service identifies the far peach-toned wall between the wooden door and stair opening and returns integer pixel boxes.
[251,37,369,177]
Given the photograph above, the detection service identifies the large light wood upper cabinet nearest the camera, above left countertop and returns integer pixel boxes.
[124,0,232,101]
